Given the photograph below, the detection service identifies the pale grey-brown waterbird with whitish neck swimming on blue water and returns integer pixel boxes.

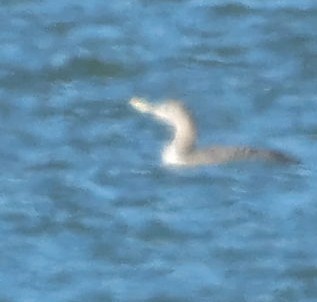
[129,97,297,167]
